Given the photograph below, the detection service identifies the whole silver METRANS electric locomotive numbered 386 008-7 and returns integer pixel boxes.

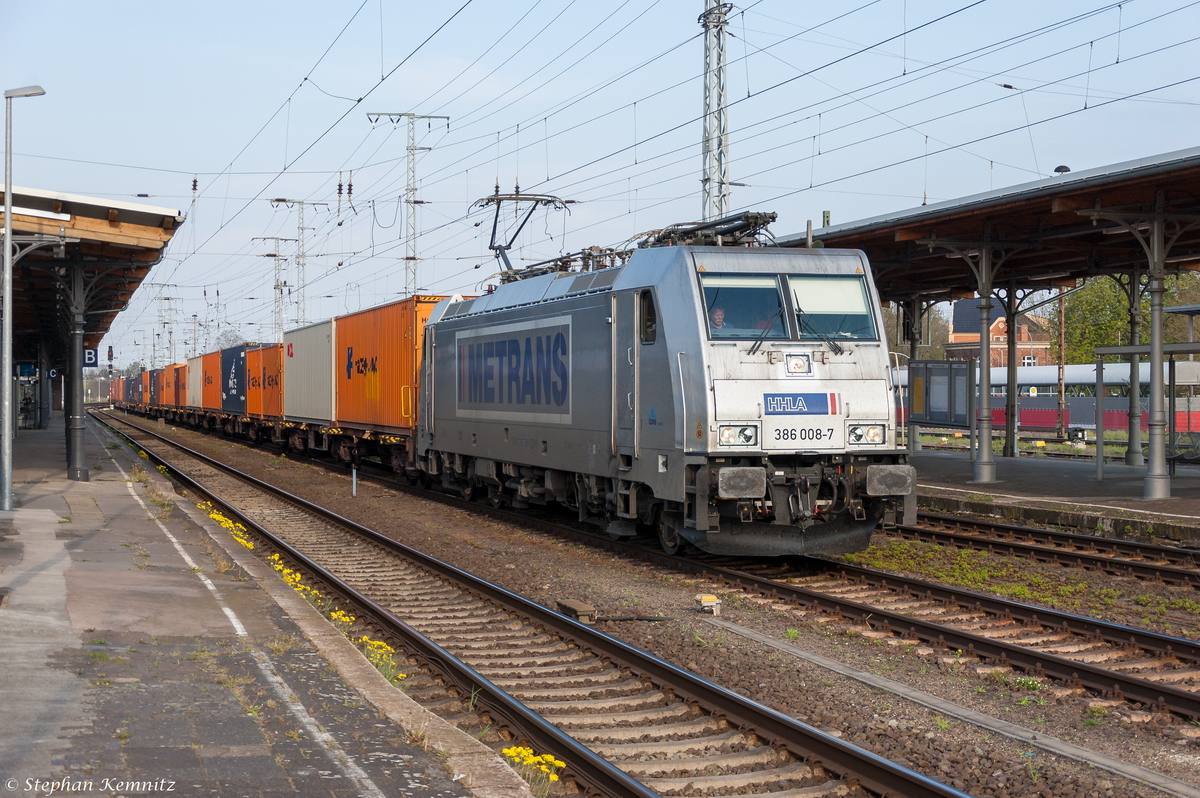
[416,240,916,554]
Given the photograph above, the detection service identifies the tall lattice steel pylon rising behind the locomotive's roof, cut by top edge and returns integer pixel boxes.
[696,0,733,222]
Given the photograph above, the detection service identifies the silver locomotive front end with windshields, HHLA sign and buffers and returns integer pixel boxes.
[660,250,914,553]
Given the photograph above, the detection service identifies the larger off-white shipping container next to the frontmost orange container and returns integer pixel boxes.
[283,319,337,426]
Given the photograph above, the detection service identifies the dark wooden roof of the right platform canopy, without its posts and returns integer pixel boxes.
[779,148,1200,301]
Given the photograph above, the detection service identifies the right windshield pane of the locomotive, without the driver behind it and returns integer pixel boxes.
[787,275,877,341]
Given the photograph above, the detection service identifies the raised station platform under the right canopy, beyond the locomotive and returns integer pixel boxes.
[910,449,1200,546]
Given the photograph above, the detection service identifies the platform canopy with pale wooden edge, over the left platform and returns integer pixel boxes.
[0,186,184,366]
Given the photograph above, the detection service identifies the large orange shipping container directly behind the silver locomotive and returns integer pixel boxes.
[334,296,444,433]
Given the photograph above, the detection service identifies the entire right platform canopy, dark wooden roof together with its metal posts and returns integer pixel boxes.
[779,148,1200,499]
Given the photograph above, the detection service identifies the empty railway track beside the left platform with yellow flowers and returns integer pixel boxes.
[98,415,964,798]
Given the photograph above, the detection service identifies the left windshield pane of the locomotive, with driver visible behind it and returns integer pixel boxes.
[700,274,787,338]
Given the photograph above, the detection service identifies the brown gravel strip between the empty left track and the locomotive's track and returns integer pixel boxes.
[142,427,1200,798]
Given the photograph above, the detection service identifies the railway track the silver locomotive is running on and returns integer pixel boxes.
[100,410,1200,719]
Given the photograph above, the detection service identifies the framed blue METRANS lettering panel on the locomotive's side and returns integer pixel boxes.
[455,318,571,424]
